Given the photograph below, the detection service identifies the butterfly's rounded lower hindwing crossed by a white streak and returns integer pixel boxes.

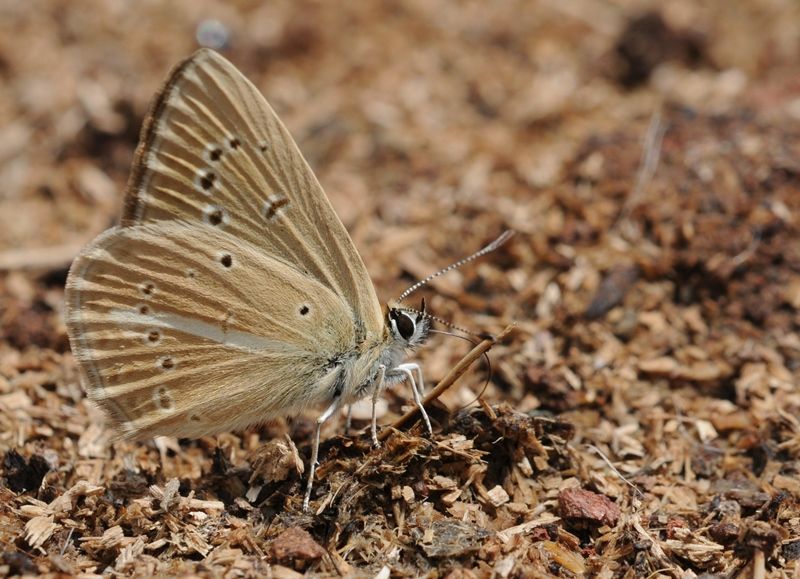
[67,222,354,436]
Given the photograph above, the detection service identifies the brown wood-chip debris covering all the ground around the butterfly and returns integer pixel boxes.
[0,0,800,579]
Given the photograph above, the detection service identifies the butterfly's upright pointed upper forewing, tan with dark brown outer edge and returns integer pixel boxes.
[122,49,384,342]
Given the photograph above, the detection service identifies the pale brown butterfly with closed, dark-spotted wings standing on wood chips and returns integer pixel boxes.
[66,49,508,508]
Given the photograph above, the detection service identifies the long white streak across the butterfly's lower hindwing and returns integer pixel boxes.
[109,310,286,352]
